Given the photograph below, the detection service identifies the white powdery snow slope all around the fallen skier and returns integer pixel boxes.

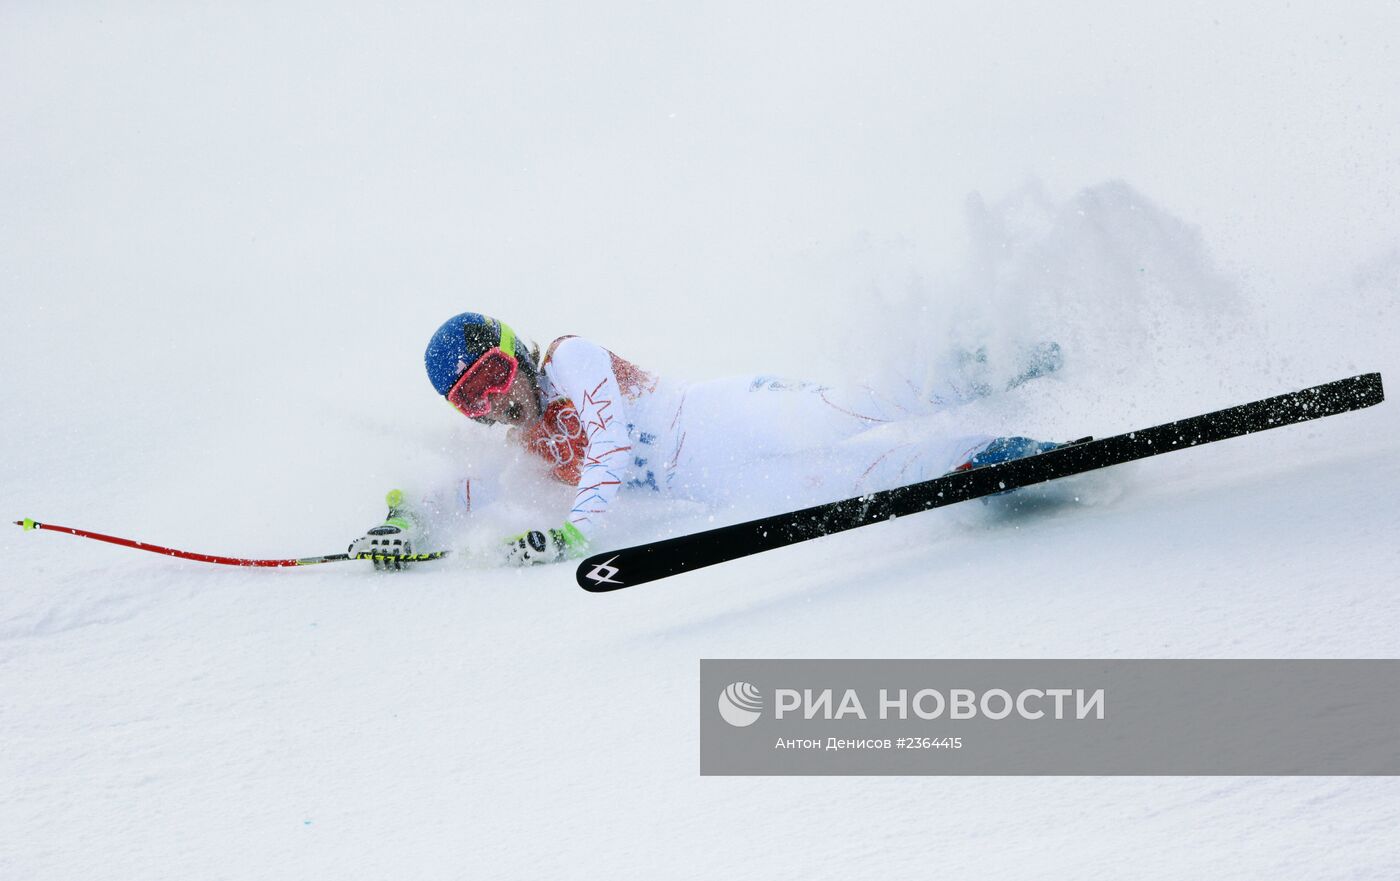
[0,1,1400,880]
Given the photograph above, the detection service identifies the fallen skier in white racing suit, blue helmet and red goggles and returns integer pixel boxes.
[350,312,1061,569]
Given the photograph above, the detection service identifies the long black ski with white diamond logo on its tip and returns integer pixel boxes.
[577,373,1385,592]
